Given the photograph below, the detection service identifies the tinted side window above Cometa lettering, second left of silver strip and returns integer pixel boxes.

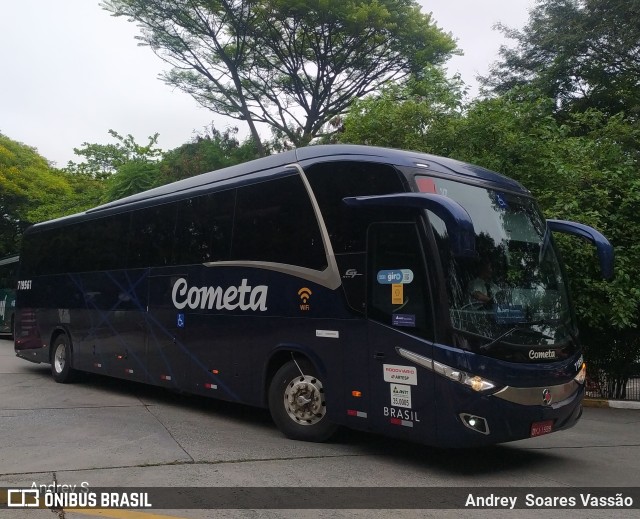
[174,190,235,265]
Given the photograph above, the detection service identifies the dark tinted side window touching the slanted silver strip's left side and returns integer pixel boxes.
[232,175,327,270]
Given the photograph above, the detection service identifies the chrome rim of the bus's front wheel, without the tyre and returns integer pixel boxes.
[284,375,327,425]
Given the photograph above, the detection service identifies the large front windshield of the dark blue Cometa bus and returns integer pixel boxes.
[418,177,575,361]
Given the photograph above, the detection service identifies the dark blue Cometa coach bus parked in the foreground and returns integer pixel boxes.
[15,145,613,447]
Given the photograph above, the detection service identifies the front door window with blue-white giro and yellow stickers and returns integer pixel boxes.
[367,223,433,338]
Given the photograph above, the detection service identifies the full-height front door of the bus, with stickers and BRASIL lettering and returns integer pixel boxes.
[367,223,436,443]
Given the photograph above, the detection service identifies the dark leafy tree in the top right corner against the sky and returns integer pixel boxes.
[483,0,640,120]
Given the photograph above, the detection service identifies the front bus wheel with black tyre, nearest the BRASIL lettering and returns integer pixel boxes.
[269,361,337,442]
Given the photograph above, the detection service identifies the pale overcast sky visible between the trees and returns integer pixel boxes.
[0,0,535,167]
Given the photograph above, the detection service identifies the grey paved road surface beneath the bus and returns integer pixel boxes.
[0,340,640,519]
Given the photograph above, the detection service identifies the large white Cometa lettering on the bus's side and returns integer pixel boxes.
[171,278,269,312]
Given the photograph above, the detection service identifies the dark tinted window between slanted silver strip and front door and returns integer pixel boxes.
[306,162,406,254]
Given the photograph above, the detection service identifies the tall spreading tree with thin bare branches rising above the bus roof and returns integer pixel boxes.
[102,0,455,155]
